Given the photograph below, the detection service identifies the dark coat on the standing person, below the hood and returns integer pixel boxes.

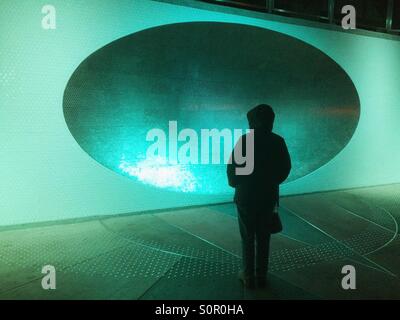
[227,129,291,211]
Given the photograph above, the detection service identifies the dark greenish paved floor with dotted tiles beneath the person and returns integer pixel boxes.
[0,184,400,299]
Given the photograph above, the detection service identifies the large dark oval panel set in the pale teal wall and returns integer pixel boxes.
[63,22,360,195]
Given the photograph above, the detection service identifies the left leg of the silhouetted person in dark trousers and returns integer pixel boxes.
[238,206,255,287]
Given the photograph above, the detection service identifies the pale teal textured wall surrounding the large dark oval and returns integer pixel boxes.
[0,0,400,225]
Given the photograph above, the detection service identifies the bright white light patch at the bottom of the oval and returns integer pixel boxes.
[119,157,197,192]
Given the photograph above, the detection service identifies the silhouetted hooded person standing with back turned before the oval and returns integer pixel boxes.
[227,105,291,288]
